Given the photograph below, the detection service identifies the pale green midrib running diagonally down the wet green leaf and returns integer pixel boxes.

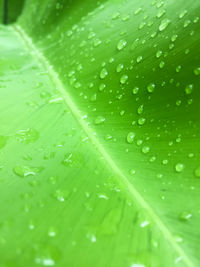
[10,24,194,267]
